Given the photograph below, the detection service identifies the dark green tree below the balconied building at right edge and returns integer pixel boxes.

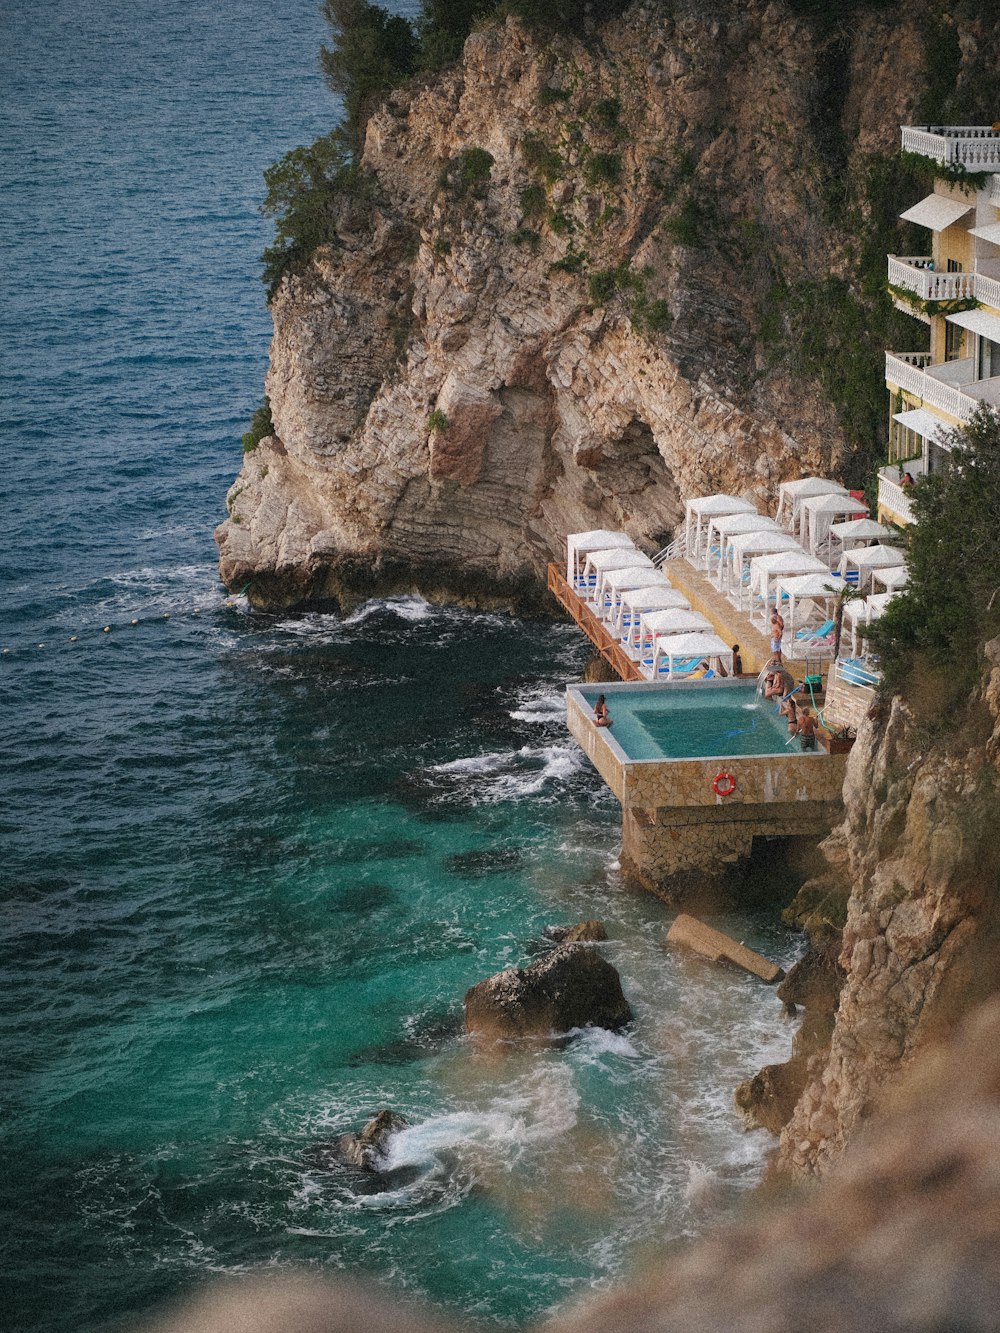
[869,407,1000,702]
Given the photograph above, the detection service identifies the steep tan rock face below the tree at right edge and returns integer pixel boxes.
[779,655,1000,1174]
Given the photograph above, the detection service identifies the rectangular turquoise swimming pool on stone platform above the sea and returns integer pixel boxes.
[580,682,799,760]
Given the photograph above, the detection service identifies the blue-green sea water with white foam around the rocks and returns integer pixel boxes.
[0,0,796,1333]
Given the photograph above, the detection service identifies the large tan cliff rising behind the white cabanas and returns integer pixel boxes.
[217,0,938,607]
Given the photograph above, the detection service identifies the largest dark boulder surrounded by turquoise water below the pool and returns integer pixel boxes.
[465,944,632,1040]
